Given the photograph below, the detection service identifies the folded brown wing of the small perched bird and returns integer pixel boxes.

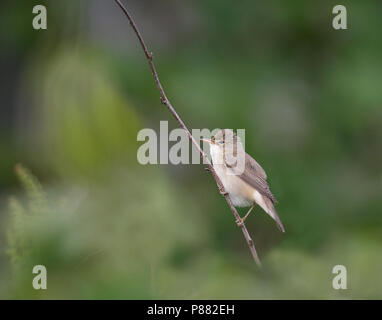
[227,153,277,203]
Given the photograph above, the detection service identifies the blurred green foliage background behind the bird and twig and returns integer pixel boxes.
[0,0,382,299]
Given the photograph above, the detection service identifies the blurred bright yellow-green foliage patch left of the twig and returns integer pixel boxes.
[27,45,141,179]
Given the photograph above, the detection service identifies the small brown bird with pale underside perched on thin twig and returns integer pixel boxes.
[201,129,285,232]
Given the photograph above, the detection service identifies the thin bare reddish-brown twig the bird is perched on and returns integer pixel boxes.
[114,0,261,267]
